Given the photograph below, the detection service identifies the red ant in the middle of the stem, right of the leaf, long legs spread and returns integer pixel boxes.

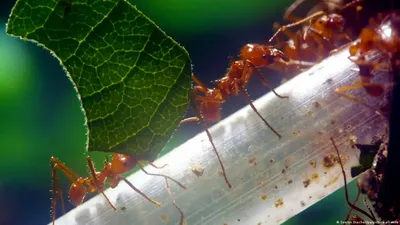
[181,44,308,188]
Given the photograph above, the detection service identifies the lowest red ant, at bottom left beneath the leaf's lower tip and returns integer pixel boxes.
[50,153,186,225]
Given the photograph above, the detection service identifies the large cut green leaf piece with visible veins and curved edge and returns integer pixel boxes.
[7,0,192,155]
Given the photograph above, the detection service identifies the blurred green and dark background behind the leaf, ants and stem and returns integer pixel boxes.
[0,0,355,225]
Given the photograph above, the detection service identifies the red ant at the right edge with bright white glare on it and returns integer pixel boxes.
[335,13,400,110]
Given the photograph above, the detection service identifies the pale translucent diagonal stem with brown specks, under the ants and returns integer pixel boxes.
[51,50,390,225]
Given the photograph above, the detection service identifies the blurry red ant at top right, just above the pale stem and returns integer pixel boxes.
[260,0,362,76]
